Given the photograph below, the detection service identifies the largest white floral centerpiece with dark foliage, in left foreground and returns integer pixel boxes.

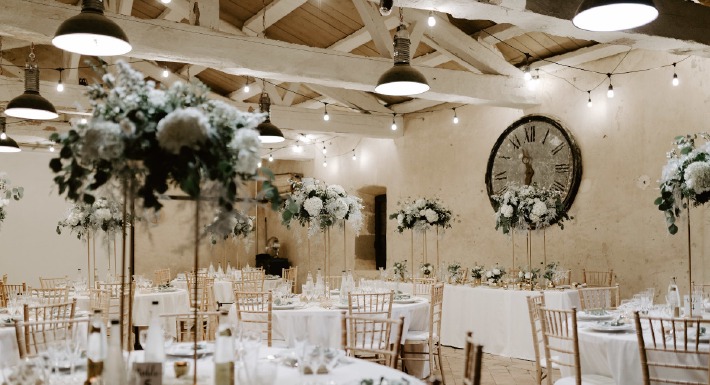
[49,62,279,220]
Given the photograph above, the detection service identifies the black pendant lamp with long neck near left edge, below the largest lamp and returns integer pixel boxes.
[5,44,59,120]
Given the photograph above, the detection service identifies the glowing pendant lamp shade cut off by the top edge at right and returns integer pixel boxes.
[572,0,658,32]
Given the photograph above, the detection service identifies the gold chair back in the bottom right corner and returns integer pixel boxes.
[634,312,710,385]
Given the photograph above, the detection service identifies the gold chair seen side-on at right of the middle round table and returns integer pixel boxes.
[400,283,446,383]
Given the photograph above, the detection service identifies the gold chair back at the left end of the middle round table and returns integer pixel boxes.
[234,291,273,346]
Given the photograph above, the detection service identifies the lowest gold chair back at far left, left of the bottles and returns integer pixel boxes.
[15,318,89,359]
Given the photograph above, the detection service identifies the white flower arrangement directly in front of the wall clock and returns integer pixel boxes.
[492,183,570,234]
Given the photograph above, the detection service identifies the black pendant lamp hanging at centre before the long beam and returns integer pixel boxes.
[375,23,429,96]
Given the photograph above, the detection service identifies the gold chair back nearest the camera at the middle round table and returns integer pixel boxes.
[341,312,404,369]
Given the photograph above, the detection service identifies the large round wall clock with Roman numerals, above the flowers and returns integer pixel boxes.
[486,115,582,210]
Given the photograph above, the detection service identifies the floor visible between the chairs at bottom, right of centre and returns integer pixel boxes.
[434,347,559,385]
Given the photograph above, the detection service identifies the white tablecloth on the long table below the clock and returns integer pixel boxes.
[441,284,579,360]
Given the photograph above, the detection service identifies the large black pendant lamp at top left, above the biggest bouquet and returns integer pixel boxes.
[52,0,132,56]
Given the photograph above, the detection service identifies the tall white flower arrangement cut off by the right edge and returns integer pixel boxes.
[654,132,710,234]
